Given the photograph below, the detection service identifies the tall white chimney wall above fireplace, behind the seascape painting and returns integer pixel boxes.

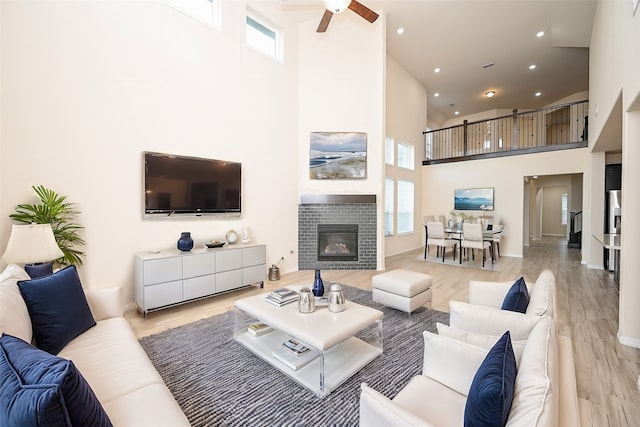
[295,9,386,269]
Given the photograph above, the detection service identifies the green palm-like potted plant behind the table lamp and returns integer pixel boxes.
[9,185,85,266]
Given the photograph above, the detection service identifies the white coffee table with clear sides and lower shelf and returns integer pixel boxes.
[234,286,383,397]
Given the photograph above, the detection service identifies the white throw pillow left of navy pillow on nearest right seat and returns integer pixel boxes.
[422,331,489,396]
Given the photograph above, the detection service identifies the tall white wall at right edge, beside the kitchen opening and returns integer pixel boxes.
[589,0,640,347]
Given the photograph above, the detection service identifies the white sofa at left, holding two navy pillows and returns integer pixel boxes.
[0,265,189,427]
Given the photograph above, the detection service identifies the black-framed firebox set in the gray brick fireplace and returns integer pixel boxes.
[318,224,358,261]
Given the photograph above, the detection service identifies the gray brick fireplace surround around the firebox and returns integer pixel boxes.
[298,194,378,270]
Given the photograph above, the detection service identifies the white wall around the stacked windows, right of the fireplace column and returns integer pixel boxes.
[381,56,427,256]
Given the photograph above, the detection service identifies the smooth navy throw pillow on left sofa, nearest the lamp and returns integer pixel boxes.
[18,265,96,354]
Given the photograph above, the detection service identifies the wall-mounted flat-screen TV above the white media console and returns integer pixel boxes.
[143,152,242,216]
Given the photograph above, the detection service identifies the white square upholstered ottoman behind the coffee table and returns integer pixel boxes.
[371,270,432,313]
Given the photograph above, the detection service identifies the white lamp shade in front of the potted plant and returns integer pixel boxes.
[2,224,64,264]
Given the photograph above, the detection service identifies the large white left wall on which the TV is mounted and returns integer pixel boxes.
[0,1,298,302]
